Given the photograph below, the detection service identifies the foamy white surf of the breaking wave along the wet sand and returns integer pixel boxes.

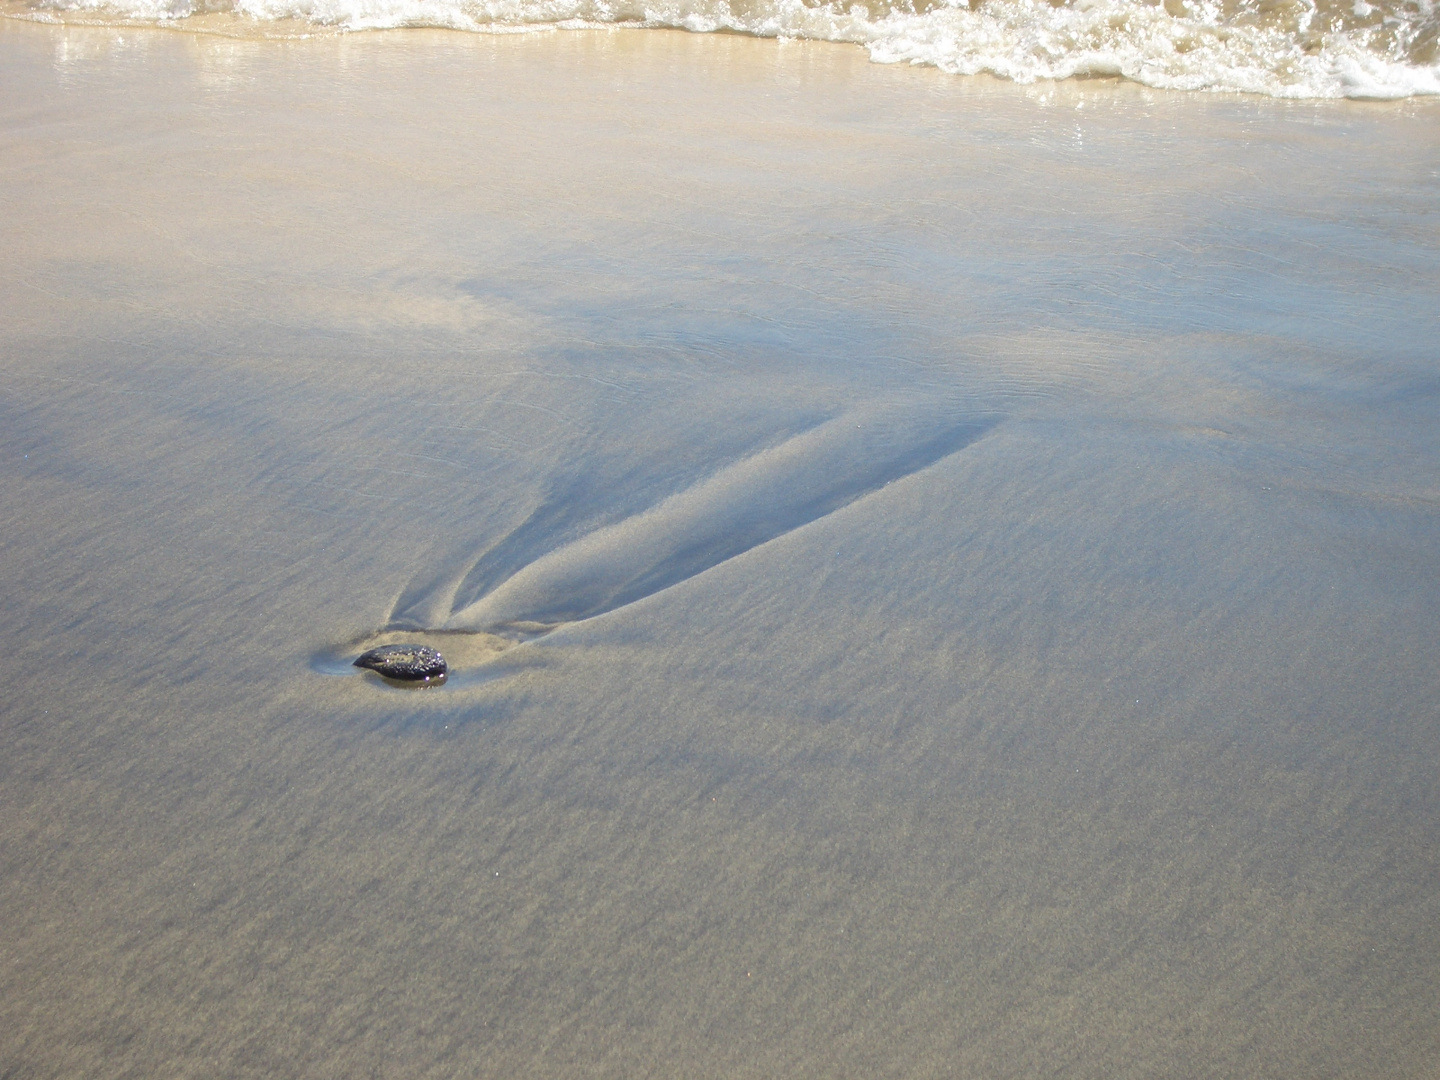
[6,0,1440,98]
